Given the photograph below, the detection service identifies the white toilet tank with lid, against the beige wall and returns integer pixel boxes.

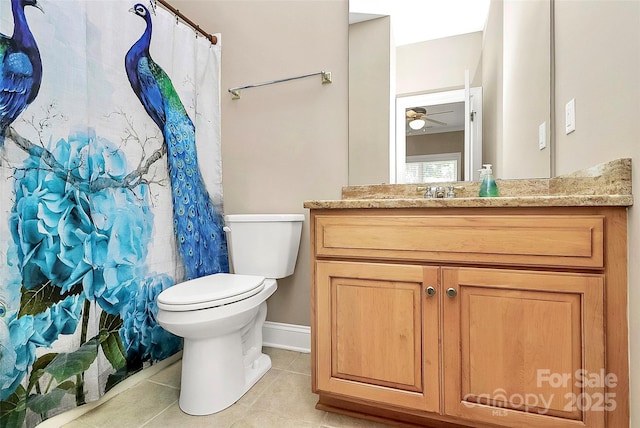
[224,214,304,279]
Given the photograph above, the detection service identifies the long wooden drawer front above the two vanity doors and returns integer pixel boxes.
[315,215,604,268]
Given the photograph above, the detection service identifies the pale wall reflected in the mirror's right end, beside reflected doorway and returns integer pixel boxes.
[482,0,551,178]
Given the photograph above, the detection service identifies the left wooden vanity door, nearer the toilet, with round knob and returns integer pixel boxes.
[314,261,440,412]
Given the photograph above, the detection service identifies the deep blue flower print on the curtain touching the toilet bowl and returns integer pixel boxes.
[120,275,182,361]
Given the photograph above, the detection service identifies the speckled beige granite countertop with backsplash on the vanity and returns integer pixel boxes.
[304,158,633,209]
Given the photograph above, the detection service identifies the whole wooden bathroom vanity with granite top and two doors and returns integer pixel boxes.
[305,159,632,428]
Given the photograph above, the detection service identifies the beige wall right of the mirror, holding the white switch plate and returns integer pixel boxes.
[555,0,640,428]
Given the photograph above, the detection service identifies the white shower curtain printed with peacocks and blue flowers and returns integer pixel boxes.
[0,0,228,427]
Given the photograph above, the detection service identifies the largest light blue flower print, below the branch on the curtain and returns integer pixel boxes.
[10,131,153,314]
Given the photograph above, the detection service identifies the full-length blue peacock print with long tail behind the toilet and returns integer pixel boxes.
[126,3,229,279]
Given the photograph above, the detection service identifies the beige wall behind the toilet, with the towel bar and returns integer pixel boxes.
[171,0,348,325]
